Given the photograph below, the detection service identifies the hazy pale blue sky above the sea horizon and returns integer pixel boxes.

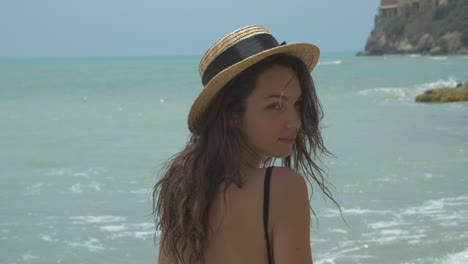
[0,0,380,58]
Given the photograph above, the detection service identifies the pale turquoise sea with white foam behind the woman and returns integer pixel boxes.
[0,53,468,264]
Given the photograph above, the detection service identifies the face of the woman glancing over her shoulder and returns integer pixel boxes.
[240,66,302,165]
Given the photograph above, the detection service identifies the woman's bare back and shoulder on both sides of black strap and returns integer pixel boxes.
[205,168,312,264]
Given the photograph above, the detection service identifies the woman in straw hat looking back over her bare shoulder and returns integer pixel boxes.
[153,26,334,264]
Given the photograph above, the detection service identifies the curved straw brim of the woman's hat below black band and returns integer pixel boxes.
[188,43,320,134]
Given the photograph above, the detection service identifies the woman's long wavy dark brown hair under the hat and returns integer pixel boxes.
[153,54,336,264]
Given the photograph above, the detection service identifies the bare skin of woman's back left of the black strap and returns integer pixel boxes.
[205,169,267,264]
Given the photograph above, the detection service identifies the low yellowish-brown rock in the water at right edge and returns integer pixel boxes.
[415,83,468,103]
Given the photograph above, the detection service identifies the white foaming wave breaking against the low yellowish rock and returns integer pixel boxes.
[358,77,457,102]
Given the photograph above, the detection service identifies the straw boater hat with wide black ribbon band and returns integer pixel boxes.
[188,26,320,135]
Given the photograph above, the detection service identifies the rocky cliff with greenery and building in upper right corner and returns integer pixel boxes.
[358,0,468,55]
